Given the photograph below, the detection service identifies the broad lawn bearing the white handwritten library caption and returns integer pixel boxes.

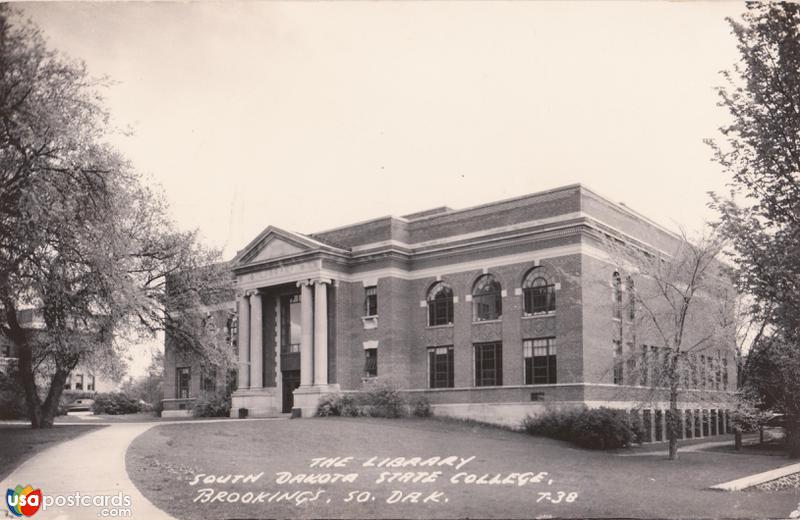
[126,418,798,519]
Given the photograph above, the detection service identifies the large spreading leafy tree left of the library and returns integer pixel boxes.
[0,5,231,428]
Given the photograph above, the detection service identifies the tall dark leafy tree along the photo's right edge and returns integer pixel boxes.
[708,3,800,457]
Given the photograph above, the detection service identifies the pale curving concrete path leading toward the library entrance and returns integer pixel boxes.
[0,419,285,520]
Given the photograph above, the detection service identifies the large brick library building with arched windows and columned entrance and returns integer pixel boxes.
[165,185,735,440]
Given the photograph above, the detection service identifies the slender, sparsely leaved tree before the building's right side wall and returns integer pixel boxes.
[604,232,736,459]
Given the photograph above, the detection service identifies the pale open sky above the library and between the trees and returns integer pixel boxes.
[18,1,744,378]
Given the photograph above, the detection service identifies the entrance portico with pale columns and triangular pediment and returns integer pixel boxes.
[231,228,346,417]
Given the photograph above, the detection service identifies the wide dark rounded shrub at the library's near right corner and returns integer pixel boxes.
[523,407,641,449]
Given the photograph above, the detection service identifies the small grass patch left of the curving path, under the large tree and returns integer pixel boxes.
[0,424,103,484]
